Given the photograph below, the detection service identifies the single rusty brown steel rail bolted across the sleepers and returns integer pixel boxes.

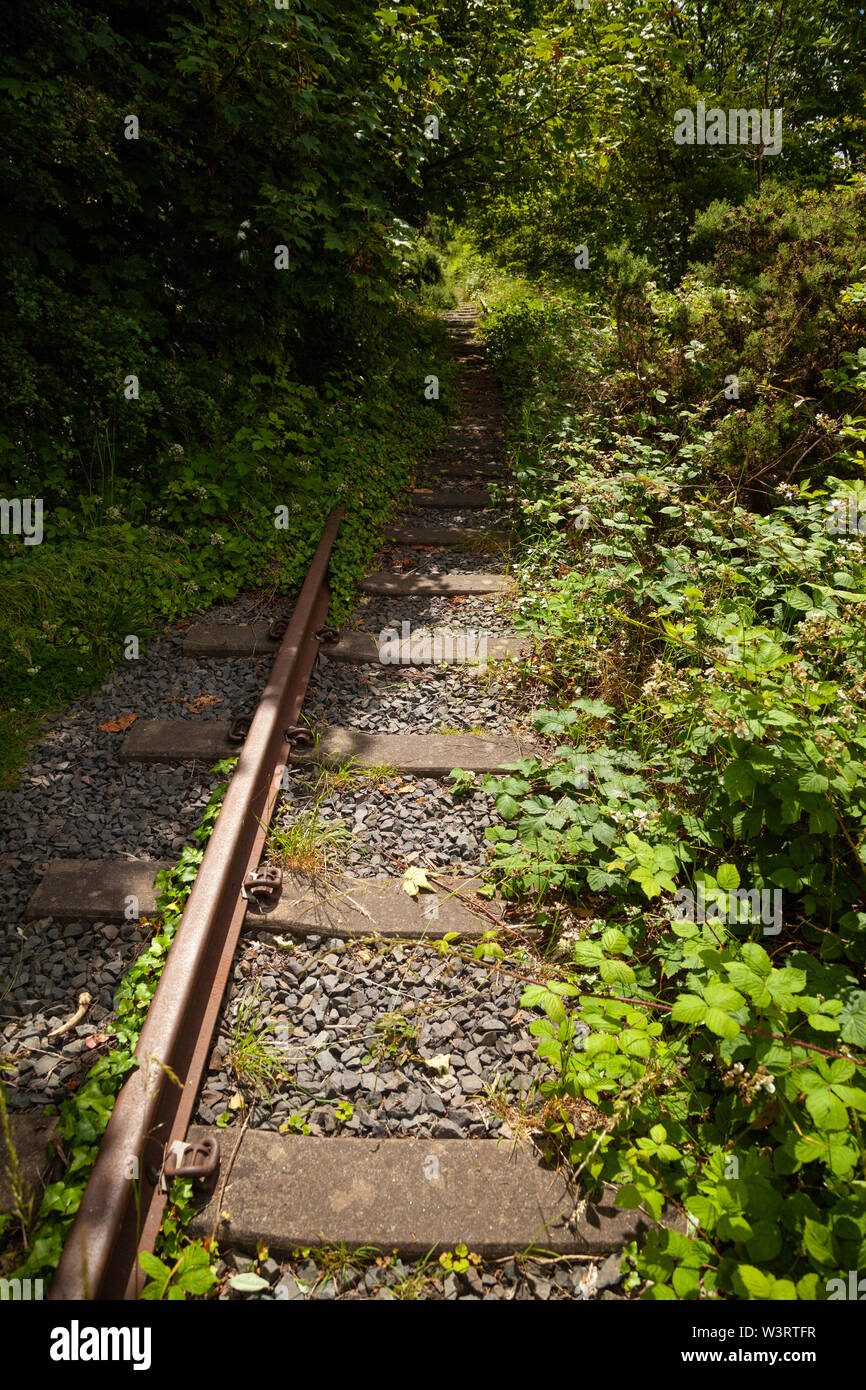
[49,507,345,1300]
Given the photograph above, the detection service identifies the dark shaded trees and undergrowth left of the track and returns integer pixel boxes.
[0,0,467,778]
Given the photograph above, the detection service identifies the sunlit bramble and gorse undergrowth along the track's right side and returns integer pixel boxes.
[467,168,866,1300]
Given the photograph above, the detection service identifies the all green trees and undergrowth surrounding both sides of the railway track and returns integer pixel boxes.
[0,0,866,1300]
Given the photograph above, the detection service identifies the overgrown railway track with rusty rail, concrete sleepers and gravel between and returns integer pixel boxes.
[5,310,664,1300]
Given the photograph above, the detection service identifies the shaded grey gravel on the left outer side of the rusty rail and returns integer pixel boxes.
[0,595,279,1108]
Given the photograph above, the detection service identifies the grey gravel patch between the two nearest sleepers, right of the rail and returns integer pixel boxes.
[199,937,588,1138]
